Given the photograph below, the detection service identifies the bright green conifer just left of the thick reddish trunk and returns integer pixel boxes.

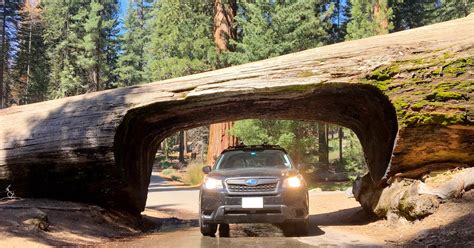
[145,0,217,80]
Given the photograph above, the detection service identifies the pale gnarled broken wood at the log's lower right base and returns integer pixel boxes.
[353,168,474,220]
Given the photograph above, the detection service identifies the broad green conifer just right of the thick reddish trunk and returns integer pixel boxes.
[226,0,334,64]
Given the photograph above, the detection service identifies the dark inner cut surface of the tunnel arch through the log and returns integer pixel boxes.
[114,83,398,213]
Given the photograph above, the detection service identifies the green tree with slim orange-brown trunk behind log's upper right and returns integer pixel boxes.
[346,0,393,40]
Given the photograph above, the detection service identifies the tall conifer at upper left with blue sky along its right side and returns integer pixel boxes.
[43,0,118,98]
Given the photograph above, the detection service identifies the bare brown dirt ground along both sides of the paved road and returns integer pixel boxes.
[0,190,474,247]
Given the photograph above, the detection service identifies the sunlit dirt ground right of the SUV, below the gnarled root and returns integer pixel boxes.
[310,190,474,247]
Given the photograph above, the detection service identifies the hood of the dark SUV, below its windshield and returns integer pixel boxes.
[209,167,298,178]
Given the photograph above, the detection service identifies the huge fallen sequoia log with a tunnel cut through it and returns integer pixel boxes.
[0,15,474,214]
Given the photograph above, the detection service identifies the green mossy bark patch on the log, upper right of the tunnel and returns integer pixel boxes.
[361,53,474,126]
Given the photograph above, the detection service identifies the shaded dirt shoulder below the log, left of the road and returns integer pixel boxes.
[0,199,141,247]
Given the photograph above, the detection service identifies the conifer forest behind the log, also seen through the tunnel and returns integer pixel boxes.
[0,0,474,178]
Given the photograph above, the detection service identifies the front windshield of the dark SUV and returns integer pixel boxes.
[215,150,292,170]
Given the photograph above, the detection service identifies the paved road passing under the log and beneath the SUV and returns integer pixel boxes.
[124,173,377,248]
